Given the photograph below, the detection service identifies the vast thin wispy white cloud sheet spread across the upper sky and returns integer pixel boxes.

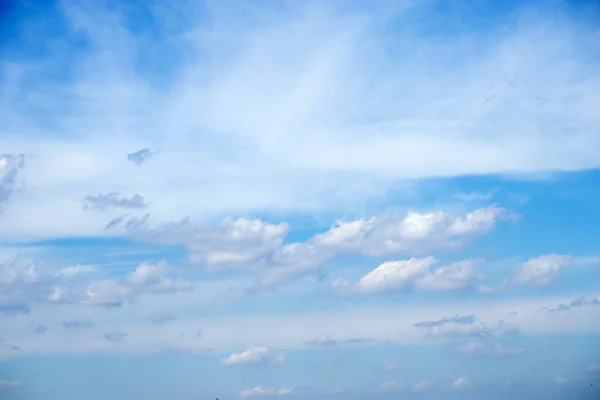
[0,2,600,244]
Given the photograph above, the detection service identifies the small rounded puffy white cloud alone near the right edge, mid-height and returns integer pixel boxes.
[515,254,573,286]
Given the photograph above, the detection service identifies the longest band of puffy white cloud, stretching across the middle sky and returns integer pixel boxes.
[123,206,511,290]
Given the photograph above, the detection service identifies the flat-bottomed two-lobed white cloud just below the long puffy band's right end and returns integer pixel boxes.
[354,256,477,293]
